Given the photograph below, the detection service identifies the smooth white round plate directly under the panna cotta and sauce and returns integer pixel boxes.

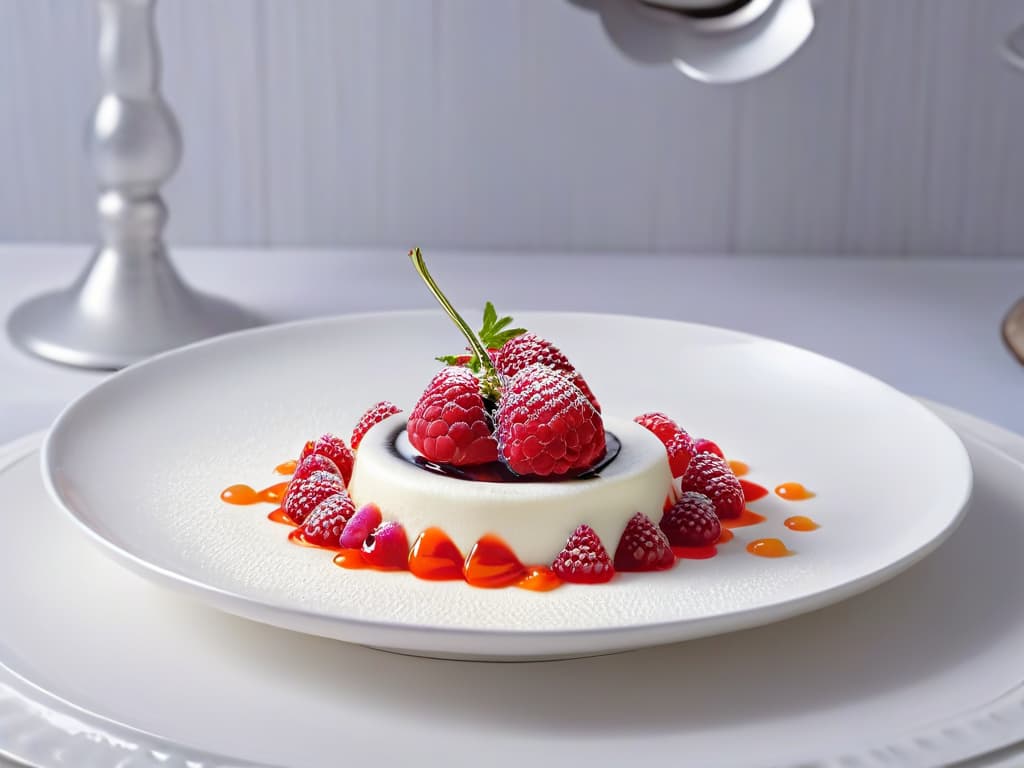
[43,312,971,658]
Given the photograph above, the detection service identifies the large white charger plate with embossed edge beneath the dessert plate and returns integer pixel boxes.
[0,410,1024,768]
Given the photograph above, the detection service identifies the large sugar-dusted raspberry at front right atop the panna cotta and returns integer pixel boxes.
[495,364,605,477]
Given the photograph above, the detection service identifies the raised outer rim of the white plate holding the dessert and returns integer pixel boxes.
[39,309,974,660]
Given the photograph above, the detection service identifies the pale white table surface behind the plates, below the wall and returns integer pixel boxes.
[0,244,1024,766]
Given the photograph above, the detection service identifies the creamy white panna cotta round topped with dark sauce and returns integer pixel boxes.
[348,416,672,565]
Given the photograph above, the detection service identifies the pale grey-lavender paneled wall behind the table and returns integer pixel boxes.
[0,0,1024,256]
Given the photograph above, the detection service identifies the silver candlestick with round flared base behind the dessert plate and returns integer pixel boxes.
[7,0,258,370]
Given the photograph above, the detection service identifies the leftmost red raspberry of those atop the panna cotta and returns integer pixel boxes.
[408,366,498,467]
